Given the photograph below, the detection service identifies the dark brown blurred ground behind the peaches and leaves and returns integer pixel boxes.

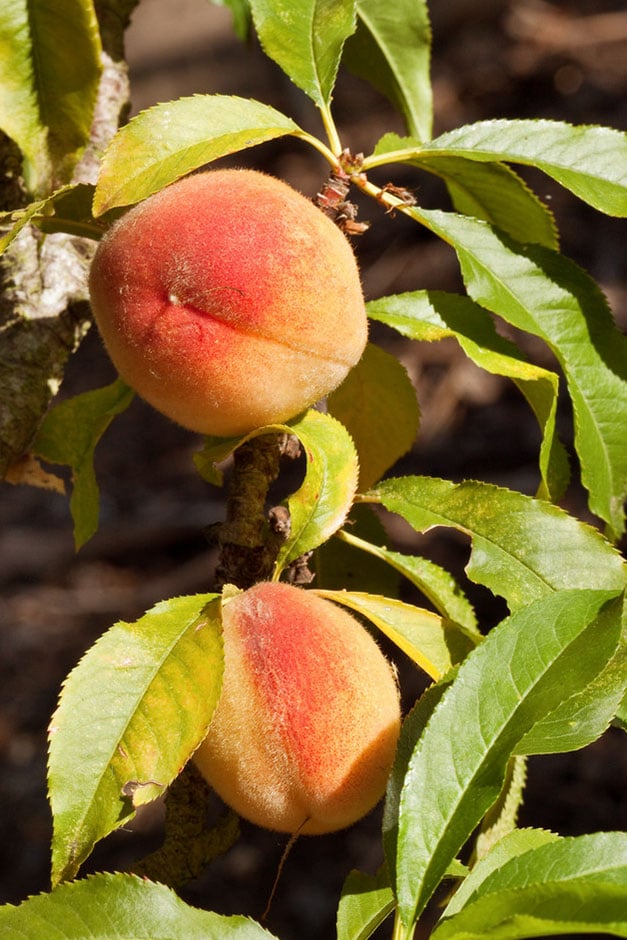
[0,0,627,940]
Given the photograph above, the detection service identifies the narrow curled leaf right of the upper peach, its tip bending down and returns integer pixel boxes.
[367,291,569,499]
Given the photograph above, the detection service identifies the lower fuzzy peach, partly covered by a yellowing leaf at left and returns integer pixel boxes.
[194,582,400,834]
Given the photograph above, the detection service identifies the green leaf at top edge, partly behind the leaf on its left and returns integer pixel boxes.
[344,0,433,140]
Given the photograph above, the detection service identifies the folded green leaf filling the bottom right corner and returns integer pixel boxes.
[432,832,627,940]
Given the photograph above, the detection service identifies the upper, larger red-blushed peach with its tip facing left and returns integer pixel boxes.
[90,170,367,436]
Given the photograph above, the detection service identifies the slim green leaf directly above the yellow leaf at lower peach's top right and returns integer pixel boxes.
[338,529,480,638]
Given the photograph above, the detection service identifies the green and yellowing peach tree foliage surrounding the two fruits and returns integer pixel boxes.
[0,0,627,940]
